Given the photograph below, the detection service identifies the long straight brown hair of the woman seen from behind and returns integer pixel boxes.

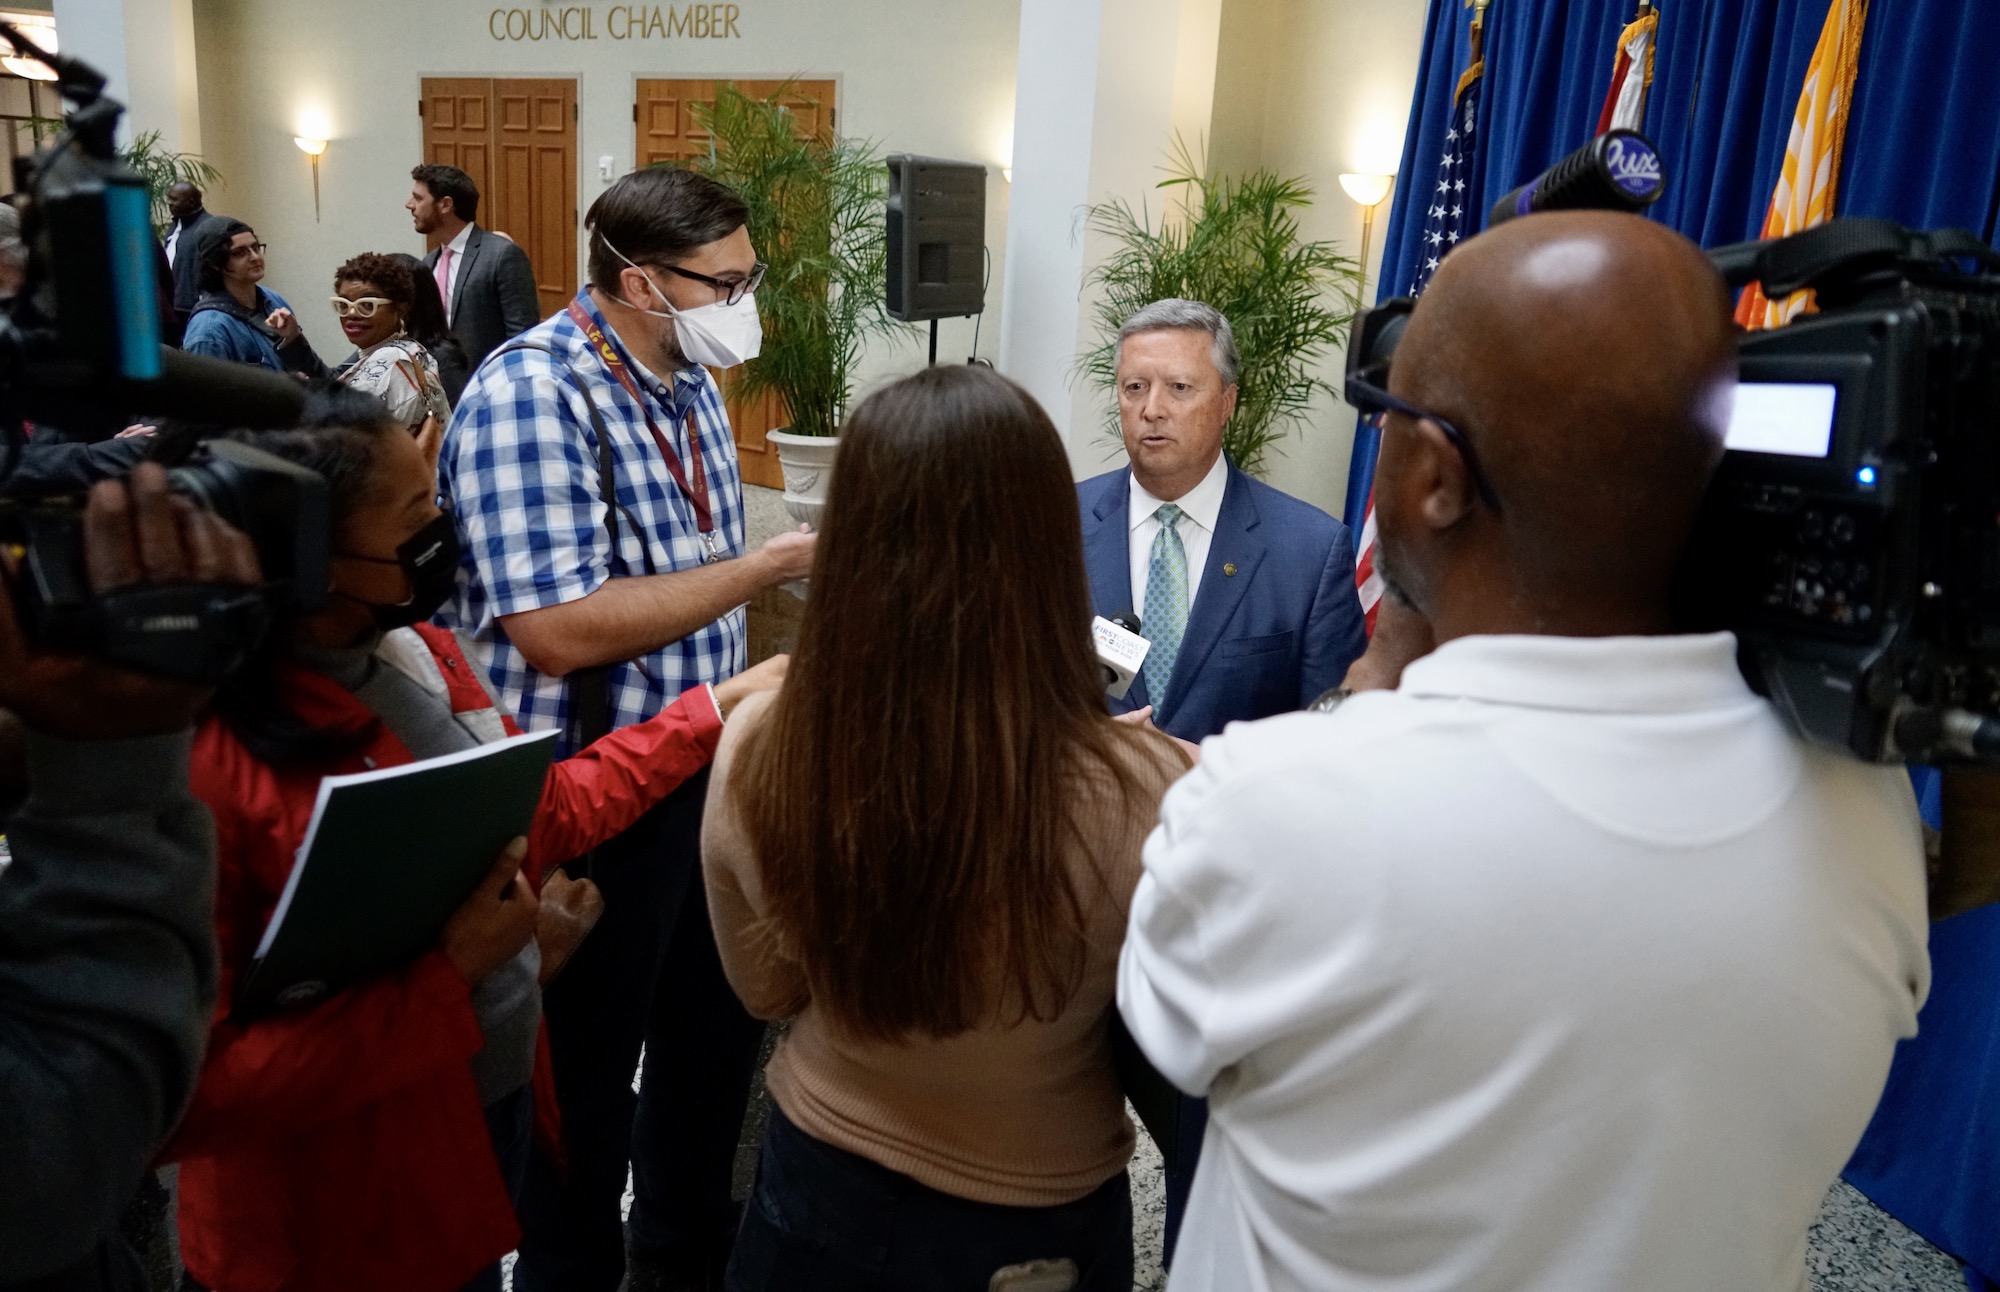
[730,366,1154,1038]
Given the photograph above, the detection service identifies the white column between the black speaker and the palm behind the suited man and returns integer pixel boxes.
[998,0,1222,476]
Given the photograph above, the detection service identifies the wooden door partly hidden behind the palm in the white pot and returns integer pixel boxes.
[632,78,834,488]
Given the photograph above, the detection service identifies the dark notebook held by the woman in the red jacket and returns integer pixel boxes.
[234,732,556,1016]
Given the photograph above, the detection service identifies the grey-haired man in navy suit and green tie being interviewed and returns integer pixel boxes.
[1076,300,1368,1258]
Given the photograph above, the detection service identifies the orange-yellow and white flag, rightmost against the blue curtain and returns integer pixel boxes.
[1736,0,1868,328]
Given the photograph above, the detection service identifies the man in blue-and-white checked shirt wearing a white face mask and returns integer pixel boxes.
[438,168,814,1292]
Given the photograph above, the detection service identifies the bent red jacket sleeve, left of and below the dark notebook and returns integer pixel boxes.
[162,730,486,1162]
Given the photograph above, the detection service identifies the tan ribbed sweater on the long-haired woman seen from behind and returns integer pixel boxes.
[702,696,1186,1206]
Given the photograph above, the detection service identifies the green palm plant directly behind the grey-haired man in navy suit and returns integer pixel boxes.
[1078,144,1362,474]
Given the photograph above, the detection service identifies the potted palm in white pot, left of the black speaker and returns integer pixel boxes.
[684,84,902,524]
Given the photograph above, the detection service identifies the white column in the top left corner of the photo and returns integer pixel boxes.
[54,0,202,152]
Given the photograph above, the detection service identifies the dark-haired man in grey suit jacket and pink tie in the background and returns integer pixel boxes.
[402,166,542,370]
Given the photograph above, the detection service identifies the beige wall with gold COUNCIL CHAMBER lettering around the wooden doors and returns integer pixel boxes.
[194,0,1018,394]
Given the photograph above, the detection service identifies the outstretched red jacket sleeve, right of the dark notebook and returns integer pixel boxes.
[528,686,722,872]
